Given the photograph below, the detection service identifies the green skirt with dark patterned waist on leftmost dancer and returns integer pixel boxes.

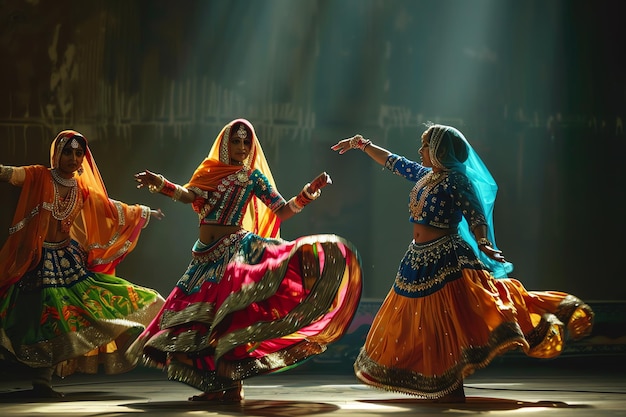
[0,240,164,377]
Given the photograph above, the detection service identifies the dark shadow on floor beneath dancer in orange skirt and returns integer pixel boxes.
[357,396,591,412]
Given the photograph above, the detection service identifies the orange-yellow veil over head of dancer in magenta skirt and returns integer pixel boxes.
[185,119,280,238]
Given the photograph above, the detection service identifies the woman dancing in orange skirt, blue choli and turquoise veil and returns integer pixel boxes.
[332,123,593,402]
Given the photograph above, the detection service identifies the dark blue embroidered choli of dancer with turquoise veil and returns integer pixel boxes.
[385,154,486,229]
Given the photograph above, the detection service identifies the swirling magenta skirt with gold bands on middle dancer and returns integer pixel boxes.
[131,231,362,392]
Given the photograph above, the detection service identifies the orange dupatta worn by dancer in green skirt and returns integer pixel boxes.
[0,130,150,287]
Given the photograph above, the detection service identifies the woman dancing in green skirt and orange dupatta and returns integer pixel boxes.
[0,130,163,397]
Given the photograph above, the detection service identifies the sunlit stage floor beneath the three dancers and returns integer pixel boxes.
[0,356,626,417]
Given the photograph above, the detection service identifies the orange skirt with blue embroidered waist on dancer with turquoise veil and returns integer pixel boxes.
[354,235,593,399]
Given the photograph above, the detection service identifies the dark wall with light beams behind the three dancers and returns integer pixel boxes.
[0,0,626,301]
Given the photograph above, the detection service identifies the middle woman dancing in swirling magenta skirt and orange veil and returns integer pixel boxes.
[130,119,361,402]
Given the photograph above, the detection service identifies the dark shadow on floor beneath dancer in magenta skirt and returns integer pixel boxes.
[124,400,340,417]
